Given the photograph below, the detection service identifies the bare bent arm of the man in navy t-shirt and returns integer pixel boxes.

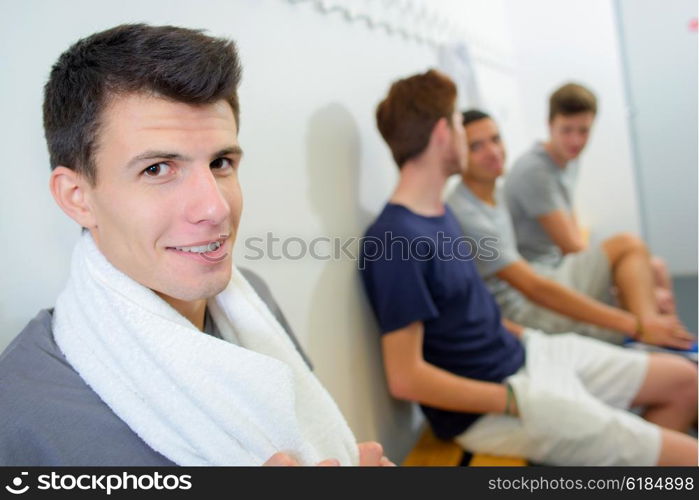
[381,322,507,413]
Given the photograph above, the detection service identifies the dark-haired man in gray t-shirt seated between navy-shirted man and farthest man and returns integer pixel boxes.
[448,110,691,347]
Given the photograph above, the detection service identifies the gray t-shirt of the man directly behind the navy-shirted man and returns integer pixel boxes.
[447,182,524,310]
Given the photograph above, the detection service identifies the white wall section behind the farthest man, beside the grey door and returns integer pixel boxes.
[505,0,641,241]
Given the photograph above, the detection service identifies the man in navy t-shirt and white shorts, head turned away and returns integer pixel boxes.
[360,70,697,465]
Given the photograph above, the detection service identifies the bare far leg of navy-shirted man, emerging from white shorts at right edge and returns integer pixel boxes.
[632,353,697,430]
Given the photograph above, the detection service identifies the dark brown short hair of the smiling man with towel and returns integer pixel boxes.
[44,24,241,185]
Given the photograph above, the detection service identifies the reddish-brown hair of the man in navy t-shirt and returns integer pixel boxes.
[376,69,456,168]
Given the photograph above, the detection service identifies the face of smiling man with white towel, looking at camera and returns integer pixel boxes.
[86,94,242,301]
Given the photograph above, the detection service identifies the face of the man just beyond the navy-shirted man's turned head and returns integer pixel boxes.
[466,118,505,182]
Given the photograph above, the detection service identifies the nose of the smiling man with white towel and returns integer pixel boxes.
[184,165,231,226]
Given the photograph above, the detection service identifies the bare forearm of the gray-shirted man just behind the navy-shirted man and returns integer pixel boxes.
[497,260,636,336]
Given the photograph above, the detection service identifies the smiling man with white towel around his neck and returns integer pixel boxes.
[0,24,390,466]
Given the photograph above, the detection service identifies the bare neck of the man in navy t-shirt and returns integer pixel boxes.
[390,158,447,217]
